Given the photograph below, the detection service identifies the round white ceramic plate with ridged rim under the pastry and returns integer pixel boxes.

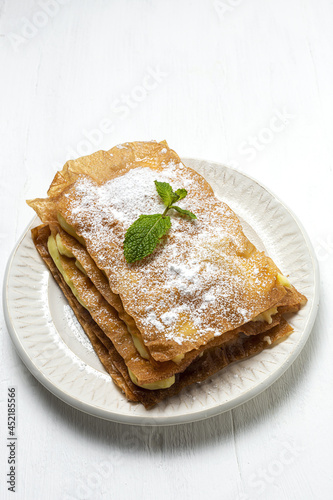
[4,159,319,425]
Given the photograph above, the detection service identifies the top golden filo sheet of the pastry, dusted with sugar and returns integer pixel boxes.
[29,142,296,364]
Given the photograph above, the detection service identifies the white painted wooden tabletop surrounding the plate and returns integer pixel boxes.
[0,0,333,500]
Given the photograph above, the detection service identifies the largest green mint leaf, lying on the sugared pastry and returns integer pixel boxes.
[124,214,171,263]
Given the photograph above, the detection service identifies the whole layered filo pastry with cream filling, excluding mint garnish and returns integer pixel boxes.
[28,141,306,408]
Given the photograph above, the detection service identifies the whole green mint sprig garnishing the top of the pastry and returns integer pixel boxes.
[124,181,196,263]
